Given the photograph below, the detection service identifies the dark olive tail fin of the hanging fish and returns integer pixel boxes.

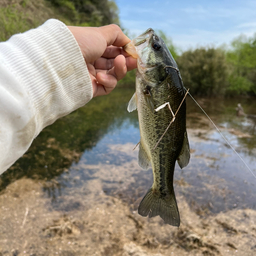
[138,188,180,227]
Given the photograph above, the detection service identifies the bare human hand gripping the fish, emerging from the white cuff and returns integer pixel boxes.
[68,25,137,97]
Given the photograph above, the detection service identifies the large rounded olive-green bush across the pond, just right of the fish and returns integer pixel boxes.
[177,48,228,96]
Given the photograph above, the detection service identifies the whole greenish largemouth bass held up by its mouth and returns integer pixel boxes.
[124,28,190,227]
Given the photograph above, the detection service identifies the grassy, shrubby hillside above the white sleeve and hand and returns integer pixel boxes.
[0,0,119,41]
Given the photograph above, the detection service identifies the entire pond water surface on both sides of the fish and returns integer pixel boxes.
[0,88,256,215]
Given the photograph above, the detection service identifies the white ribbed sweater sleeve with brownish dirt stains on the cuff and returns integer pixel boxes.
[0,20,92,174]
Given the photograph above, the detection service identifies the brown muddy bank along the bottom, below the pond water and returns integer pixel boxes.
[0,175,256,256]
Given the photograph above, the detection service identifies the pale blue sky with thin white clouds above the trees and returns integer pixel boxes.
[116,0,256,51]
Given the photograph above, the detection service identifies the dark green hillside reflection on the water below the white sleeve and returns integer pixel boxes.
[0,89,137,189]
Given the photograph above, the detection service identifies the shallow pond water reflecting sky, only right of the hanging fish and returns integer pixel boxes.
[181,99,256,212]
